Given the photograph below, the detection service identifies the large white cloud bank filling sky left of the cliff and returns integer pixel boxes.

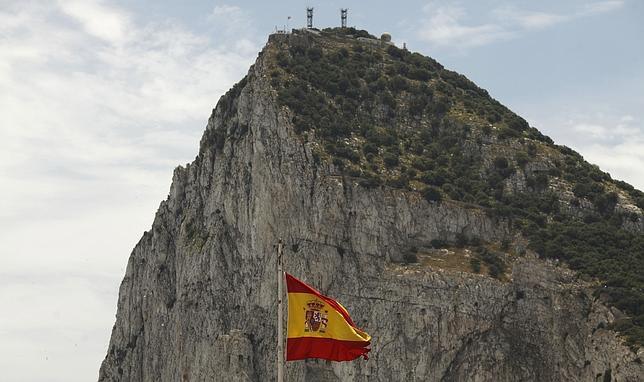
[0,0,259,381]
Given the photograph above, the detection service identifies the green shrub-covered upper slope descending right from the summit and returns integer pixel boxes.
[267,28,644,345]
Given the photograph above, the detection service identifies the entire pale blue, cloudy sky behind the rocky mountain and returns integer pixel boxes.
[0,0,644,382]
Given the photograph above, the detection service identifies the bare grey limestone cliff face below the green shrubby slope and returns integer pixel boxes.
[99,36,644,382]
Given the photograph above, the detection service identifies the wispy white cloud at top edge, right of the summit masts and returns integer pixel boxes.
[417,0,624,50]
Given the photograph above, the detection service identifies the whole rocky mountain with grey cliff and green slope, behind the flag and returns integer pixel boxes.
[99,28,644,381]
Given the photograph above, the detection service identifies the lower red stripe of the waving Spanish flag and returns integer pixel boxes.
[286,337,371,361]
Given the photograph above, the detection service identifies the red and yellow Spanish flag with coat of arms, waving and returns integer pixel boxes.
[286,273,371,361]
